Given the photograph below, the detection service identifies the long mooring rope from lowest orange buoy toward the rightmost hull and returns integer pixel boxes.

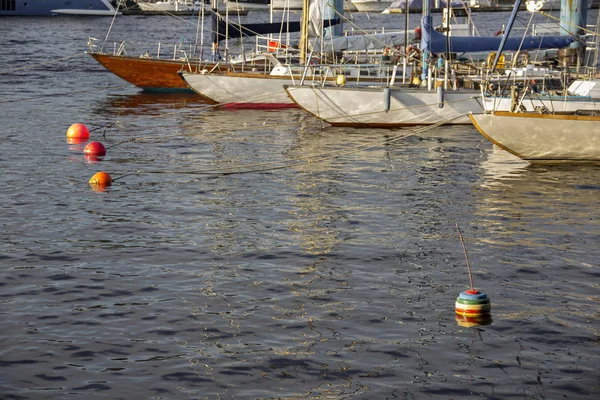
[141,119,463,176]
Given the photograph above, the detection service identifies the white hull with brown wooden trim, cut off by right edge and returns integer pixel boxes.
[470,111,600,162]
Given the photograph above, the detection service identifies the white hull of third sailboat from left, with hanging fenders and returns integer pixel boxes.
[286,86,482,128]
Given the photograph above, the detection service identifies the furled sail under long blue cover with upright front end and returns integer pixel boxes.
[421,16,576,53]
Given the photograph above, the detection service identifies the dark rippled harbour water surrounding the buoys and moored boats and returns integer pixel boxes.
[0,13,600,399]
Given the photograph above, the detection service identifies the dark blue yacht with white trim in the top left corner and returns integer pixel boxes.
[0,0,116,16]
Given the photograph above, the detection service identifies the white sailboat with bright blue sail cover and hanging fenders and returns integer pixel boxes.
[286,0,574,128]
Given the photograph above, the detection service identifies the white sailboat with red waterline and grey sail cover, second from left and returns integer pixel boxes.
[180,0,414,108]
